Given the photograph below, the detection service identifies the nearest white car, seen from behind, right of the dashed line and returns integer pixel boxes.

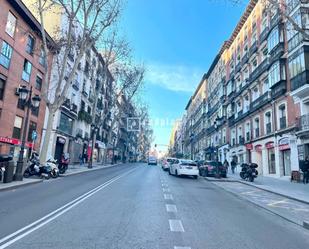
[169,159,199,179]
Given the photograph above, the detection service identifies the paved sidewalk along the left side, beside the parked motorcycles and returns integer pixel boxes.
[0,163,120,191]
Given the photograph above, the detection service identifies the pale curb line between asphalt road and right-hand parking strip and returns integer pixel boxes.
[209,181,309,230]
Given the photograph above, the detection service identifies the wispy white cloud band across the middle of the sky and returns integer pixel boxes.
[145,64,204,93]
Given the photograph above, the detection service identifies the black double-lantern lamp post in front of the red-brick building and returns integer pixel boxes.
[15,86,41,181]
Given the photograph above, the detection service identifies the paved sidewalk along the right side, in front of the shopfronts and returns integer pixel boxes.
[206,173,309,204]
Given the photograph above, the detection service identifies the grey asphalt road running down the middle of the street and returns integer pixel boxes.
[0,164,309,249]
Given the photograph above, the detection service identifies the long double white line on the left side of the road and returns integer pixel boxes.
[0,167,138,249]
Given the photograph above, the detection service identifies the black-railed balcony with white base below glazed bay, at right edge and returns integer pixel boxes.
[291,70,309,99]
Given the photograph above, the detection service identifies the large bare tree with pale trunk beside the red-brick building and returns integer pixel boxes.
[31,0,121,161]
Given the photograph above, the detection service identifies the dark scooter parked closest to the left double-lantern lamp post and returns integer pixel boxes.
[24,152,52,179]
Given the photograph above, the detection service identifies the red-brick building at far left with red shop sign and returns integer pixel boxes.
[0,0,52,160]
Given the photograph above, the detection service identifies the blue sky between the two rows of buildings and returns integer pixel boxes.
[121,0,246,150]
